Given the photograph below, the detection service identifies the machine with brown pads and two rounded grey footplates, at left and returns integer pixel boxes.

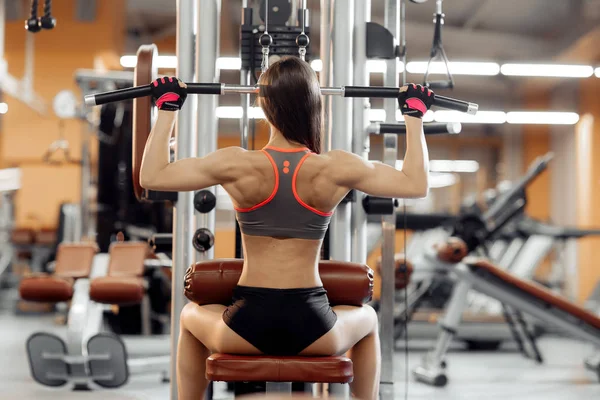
[20,242,170,390]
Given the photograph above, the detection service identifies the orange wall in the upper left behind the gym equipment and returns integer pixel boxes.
[0,0,125,227]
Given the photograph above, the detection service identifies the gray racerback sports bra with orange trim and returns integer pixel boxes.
[235,146,333,240]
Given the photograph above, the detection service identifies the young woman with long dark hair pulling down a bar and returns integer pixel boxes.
[141,58,434,399]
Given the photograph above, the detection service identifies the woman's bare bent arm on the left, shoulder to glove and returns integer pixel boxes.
[140,111,245,192]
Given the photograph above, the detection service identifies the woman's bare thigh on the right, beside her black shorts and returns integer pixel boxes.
[300,305,377,356]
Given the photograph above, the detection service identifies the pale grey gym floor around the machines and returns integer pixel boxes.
[0,289,600,400]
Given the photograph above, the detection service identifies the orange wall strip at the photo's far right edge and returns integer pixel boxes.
[575,79,600,302]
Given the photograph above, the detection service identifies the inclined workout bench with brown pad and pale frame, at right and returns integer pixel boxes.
[413,155,600,386]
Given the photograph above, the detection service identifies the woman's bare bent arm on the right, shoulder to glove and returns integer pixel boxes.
[324,116,429,198]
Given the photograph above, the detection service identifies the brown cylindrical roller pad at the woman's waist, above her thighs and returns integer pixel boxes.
[185,258,373,306]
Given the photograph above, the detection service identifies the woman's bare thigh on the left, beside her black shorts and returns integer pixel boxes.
[181,303,260,354]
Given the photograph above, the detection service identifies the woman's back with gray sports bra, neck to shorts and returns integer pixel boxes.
[223,146,345,288]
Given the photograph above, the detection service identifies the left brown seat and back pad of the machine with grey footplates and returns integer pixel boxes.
[19,243,98,303]
